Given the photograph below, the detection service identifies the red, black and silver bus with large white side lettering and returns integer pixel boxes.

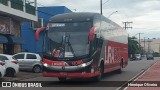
[37,13,128,81]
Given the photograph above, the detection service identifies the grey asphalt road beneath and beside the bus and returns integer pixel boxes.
[0,58,159,90]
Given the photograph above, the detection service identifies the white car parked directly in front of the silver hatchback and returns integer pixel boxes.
[0,54,19,77]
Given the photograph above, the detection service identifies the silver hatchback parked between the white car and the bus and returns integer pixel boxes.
[13,52,42,73]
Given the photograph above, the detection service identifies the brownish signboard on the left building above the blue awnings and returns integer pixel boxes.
[0,16,14,34]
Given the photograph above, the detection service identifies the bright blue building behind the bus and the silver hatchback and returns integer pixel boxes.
[21,6,71,53]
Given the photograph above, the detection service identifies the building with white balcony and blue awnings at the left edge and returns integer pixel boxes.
[0,0,38,54]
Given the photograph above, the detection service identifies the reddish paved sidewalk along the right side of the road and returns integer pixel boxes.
[126,60,160,90]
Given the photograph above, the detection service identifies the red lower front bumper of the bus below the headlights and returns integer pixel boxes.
[43,71,99,78]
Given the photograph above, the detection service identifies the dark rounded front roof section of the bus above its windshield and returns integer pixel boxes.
[49,12,100,22]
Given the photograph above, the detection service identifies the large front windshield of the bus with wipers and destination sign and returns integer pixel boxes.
[48,22,91,58]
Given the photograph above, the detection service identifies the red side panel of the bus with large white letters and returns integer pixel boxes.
[104,41,128,73]
